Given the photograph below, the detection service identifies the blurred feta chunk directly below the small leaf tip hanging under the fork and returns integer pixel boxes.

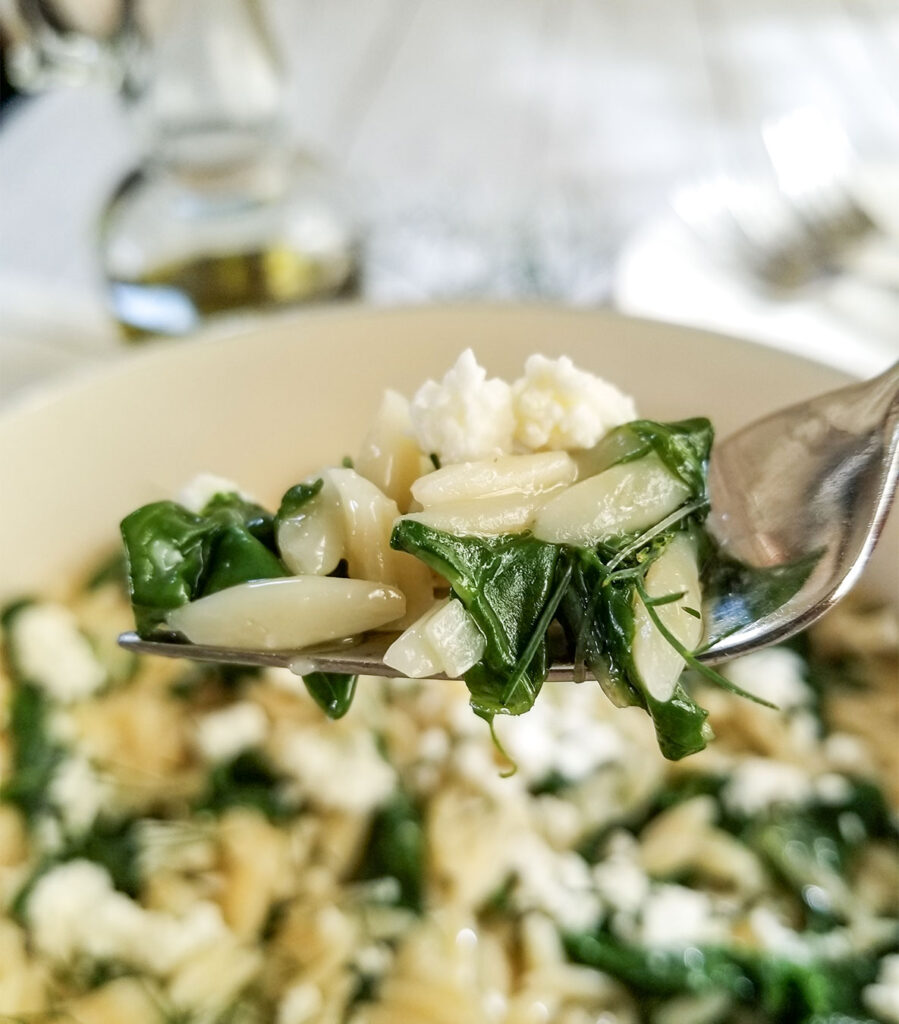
[279,728,396,814]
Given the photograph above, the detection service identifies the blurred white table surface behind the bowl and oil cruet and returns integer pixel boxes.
[0,0,899,391]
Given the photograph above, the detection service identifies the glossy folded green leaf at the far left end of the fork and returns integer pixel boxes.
[122,495,286,637]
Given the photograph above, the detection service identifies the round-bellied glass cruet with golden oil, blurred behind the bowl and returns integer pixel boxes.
[1,0,355,339]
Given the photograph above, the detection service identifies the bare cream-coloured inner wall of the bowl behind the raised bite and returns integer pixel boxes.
[0,306,899,601]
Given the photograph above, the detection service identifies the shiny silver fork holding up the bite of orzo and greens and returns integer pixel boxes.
[119,362,899,679]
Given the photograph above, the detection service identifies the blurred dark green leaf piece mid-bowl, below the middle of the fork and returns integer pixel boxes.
[355,791,426,913]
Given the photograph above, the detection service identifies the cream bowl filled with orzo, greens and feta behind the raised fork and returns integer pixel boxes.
[0,310,899,1024]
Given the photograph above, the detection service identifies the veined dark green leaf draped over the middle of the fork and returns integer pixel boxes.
[390,519,571,717]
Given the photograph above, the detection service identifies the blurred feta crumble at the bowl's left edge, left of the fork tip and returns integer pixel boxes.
[12,604,106,703]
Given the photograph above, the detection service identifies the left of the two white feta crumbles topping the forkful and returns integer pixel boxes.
[410,348,515,463]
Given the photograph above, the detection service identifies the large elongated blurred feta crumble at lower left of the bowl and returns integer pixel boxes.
[28,860,227,974]
